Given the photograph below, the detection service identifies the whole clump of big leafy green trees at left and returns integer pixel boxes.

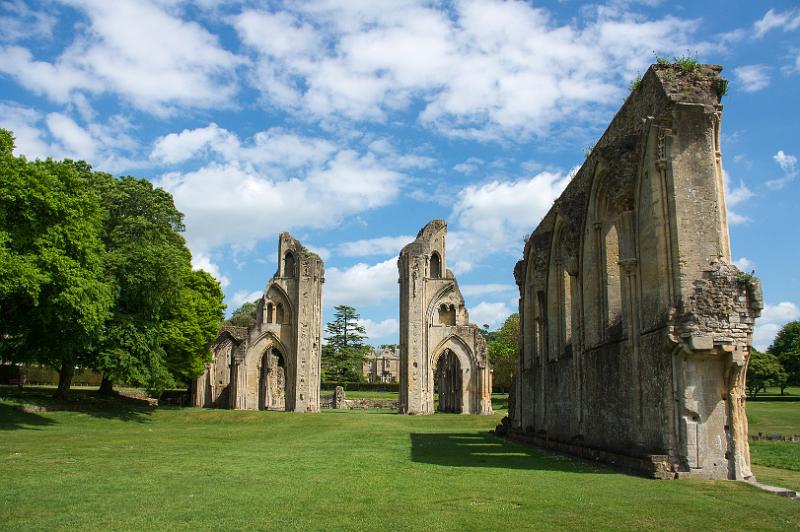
[0,131,224,394]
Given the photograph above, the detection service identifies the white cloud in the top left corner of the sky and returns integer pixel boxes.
[0,0,242,114]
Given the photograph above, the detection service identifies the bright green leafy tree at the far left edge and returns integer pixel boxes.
[0,130,113,396]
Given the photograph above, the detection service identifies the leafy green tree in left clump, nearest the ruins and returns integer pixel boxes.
[93,173,224,392]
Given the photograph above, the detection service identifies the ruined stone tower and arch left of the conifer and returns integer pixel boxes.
[192,233,325,412]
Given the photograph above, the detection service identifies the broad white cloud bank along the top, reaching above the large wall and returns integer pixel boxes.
[233,0,717,139]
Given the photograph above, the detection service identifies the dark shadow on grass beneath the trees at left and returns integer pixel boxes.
[0,387,155,430]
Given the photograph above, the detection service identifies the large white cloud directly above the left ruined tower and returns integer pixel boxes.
[151,124,402,253]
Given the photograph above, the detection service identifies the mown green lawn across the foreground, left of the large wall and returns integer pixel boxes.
[0,390,800,530]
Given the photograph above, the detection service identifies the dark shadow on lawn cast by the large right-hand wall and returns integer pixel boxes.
[411,432,612,473]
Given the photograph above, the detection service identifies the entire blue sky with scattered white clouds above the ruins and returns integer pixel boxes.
[0,0,800,348]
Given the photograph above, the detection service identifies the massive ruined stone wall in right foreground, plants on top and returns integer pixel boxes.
[506,65,763,479]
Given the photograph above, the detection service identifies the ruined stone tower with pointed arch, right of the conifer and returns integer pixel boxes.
[397,220,492,414]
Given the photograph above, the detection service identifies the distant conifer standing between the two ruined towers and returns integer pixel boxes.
[322,305,369,382]
